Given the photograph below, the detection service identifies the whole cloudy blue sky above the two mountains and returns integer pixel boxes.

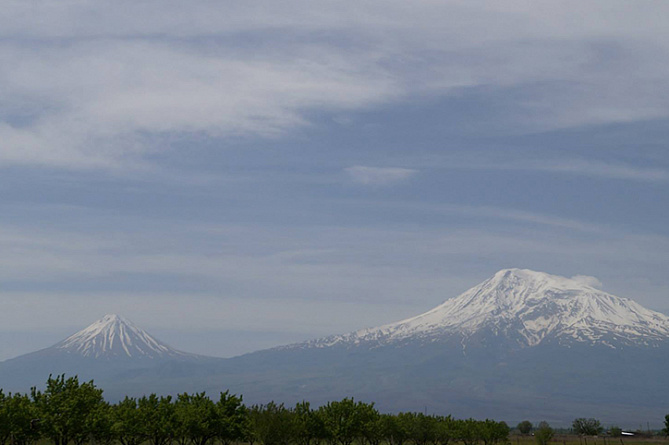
[0,0,669,360]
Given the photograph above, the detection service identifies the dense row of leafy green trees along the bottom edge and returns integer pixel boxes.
[0,375,509,445]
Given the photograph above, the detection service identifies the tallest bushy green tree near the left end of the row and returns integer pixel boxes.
[31,374,104,445]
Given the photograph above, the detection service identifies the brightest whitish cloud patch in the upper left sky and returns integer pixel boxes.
[0,38,394,168]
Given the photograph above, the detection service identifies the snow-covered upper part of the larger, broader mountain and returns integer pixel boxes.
[303,269,669,347]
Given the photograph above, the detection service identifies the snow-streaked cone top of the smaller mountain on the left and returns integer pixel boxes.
[53,314,191,359]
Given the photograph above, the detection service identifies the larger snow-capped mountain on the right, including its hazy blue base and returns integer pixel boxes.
[160,269,669,425]
